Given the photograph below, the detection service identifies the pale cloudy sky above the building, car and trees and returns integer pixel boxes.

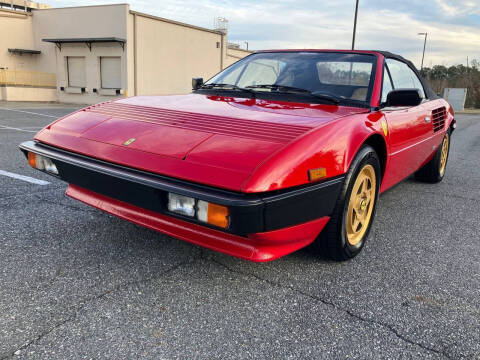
[46,0,480,67]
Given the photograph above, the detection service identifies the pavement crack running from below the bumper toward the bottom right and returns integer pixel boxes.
[207,258,452,359]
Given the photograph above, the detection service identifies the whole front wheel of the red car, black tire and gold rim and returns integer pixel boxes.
[319,145,381,260]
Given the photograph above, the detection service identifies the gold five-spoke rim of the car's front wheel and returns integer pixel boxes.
[346,165,377,245]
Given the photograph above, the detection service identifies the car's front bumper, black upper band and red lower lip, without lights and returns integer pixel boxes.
[20,141,343,261]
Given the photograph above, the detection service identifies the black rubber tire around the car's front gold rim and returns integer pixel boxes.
[317,145,381,261]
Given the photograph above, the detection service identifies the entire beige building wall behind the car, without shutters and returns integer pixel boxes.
[0,4,250,104]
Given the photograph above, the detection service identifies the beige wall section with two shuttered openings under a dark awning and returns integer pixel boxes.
[33,4,129,104]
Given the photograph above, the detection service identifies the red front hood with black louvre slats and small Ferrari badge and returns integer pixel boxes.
[36,94,366,191]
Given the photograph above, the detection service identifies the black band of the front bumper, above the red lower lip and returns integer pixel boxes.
[20,141,344,236]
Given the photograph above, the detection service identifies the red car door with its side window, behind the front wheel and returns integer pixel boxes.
[382,59,432,184]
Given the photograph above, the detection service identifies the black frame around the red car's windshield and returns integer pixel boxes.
[194,50,378,108]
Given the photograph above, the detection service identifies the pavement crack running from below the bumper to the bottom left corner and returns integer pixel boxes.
[0,259,198,360]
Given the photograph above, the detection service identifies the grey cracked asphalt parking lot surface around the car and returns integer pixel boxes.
[0,103,480,359]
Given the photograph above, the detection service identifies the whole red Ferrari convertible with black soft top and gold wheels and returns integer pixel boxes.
[20,50,455,261]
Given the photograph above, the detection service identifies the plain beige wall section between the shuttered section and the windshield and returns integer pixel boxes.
[128,12,225,95]
